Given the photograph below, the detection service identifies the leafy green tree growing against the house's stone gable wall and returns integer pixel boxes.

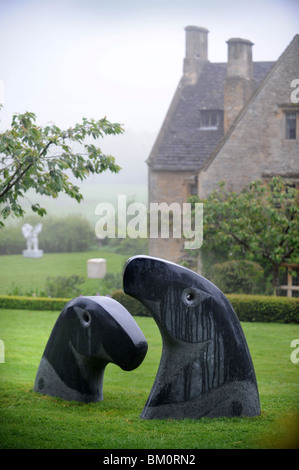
[191,177,299,292]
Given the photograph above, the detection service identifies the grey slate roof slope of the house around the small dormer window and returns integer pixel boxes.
[147,61,275,171]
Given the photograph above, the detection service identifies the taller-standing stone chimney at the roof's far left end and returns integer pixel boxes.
[184,26,209,84]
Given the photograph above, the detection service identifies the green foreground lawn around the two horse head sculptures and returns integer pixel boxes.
[0,310,299,449]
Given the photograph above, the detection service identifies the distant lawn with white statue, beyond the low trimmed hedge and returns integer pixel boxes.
[0,251,128,295]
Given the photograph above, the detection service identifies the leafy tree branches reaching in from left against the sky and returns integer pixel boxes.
[0,112,124,227]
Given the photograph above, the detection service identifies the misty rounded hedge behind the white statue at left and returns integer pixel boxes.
[0,216,94,255]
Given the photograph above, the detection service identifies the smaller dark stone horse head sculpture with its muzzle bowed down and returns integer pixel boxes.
[34,296,148,402]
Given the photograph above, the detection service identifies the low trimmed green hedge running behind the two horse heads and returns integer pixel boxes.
[0,290,299,324]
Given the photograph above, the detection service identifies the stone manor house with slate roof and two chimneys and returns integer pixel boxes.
[147,26,299,262]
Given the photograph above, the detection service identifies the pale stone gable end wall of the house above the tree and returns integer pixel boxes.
[198,35,299,197]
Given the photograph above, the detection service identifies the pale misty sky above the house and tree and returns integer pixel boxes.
[0,0,299,183]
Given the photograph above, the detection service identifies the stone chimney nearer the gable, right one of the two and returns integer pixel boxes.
[224,38,254,133]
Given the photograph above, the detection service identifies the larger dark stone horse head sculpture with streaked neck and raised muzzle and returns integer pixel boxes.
[124,256,260,419]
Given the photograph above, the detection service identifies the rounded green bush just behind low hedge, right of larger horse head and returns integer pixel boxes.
[210,260,264,294]
